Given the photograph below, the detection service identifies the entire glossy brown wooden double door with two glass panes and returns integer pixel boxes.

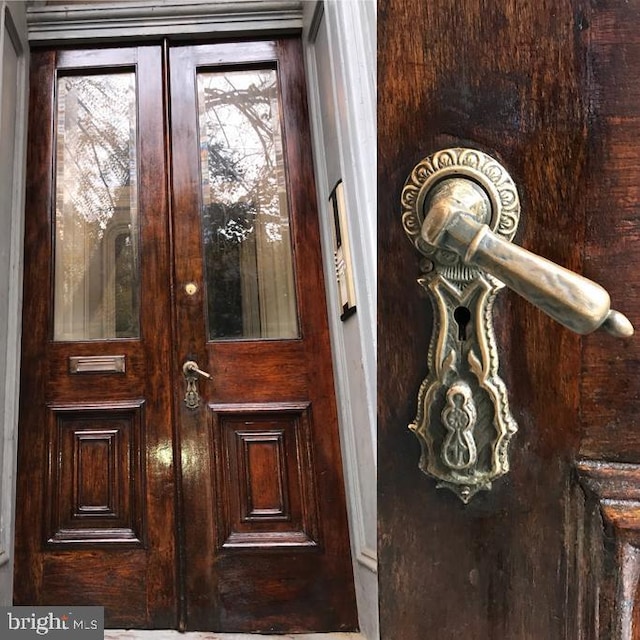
[15,38,356,632]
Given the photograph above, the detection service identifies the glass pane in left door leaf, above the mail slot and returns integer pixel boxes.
[54,72,140,340]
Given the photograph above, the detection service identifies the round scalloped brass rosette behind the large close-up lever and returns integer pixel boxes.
[401,147,520,265]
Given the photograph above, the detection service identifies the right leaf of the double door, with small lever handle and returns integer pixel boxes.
[170,38,355,631]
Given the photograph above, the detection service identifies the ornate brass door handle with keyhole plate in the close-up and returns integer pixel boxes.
[402,148,634,503]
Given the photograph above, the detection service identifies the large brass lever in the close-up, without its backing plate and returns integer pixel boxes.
[421,178,634,337]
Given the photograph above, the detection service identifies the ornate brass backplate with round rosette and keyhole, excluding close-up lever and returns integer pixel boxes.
[402,148,520,503]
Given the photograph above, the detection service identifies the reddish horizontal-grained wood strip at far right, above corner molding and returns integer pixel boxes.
[580,1,640,462]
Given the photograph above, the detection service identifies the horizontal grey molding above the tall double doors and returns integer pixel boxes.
[27,0,302,44]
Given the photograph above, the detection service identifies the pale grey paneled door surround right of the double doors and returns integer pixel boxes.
[303,0,379,640]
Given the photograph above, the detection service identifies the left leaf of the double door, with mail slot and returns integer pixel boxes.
[15,47,177,627]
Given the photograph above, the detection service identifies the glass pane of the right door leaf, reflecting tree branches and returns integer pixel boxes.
[197,69,299,340]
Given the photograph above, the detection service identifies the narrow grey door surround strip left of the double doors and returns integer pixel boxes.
[0,0,28,605]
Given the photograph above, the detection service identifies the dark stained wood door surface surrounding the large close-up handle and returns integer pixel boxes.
[378,0,640,640]
